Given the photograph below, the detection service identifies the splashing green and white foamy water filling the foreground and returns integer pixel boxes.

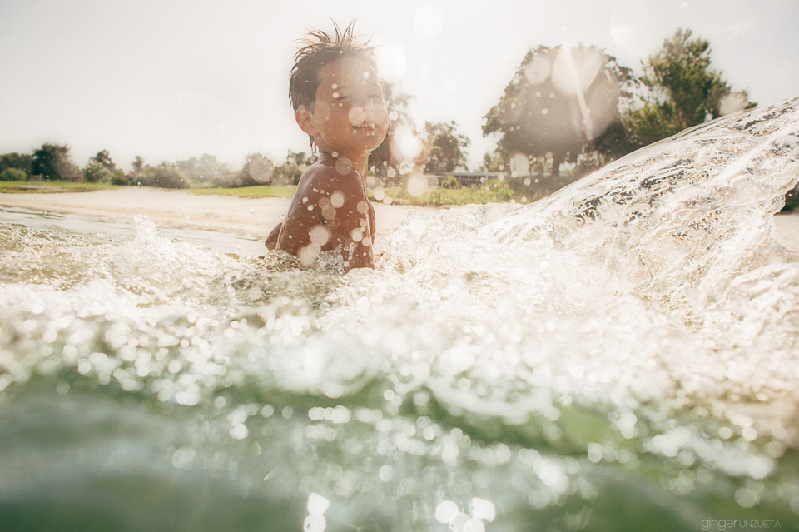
[0,100,799,532]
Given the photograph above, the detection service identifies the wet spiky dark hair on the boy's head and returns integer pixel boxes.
[289,20,377,112]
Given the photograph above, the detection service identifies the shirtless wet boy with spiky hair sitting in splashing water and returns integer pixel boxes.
[266,24,388,271]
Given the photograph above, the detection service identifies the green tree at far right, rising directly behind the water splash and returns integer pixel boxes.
[624,28,757,149]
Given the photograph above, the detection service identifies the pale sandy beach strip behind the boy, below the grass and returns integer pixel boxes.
[0,187,799,251]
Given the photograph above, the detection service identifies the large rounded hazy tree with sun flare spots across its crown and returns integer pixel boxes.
[483,46,635,175]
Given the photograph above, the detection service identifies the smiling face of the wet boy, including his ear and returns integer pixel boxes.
[296,56,388,161]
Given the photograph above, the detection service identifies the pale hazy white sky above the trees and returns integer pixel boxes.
[0,0,799,170]
